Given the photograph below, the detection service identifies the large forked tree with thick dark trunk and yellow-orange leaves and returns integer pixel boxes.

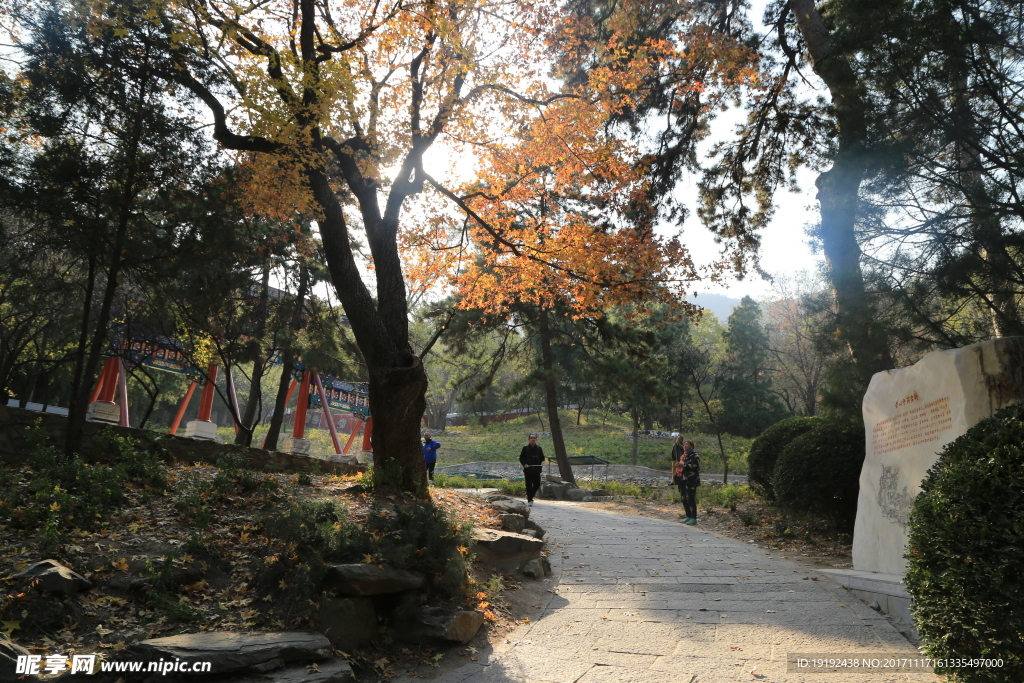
[81,0,753,494]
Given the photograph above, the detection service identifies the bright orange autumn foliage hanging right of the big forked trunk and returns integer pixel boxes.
[406,0,757,315]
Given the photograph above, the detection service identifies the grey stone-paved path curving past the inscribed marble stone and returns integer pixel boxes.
[397,501,943,683]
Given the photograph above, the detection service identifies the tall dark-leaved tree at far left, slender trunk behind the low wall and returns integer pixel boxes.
[7,5,220,455]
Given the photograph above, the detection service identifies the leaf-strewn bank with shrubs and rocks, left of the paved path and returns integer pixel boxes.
[0,434,546,683]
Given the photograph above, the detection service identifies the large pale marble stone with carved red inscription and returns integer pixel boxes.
[853,337,1024,575]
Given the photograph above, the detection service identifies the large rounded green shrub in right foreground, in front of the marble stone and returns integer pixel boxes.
[905,402,1024,683]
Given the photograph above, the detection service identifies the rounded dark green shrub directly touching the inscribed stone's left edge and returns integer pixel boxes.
[773,421,864,529]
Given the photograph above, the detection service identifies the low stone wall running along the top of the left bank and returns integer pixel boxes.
[0,405,367,474]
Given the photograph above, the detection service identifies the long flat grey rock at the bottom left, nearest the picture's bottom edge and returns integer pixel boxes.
[127,631,334,676]
